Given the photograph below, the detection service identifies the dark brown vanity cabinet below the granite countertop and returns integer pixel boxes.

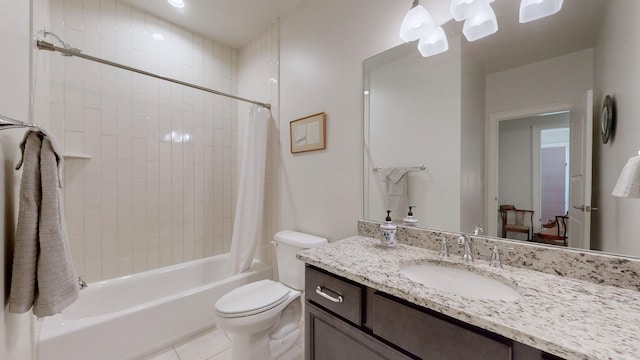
[305,266,557,360]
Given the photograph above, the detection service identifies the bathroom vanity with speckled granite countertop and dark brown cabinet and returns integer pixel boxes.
[298,231,640,360]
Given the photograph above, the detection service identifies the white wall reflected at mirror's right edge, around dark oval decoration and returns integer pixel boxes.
[591,1,640,256]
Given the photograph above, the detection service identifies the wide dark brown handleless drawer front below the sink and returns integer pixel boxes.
[373,293,511,360]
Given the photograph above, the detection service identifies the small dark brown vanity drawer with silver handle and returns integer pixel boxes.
[305,266,364,325]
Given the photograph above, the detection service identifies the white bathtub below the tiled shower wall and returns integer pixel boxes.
[38,254,271,360]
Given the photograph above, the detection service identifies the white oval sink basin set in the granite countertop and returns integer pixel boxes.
[400,262,520,301]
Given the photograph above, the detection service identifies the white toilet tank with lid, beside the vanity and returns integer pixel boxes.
[274,230,327,290]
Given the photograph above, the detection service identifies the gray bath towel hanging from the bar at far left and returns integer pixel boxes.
[9,131,79,317]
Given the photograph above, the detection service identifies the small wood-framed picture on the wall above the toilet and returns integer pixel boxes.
[289,113,326,154]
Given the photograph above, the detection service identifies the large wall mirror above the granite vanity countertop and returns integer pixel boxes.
[364,0,640,256]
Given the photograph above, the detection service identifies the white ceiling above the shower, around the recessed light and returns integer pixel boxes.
[123,0,302,48]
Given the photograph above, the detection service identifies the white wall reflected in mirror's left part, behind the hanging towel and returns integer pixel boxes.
[367,37,461,230]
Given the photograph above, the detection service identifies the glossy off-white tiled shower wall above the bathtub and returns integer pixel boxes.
[42,0,277,281]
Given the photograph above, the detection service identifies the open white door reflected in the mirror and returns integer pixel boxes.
[568,90,593,249]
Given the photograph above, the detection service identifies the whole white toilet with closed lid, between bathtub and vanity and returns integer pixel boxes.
[215,230,327,360]
